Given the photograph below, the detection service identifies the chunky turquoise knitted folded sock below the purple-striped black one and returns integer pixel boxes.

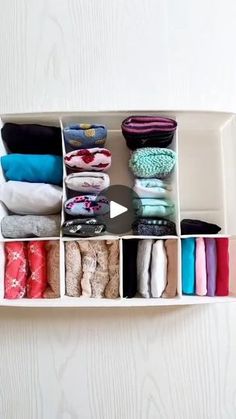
[129,147,176,179]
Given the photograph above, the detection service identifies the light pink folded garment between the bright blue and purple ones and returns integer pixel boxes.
[195,237,207,295]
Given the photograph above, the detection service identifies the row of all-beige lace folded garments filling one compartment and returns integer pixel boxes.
[65,240,119,298]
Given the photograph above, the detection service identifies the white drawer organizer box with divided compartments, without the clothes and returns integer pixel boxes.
[0,111,236,307]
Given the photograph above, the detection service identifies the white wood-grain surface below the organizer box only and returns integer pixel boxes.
[0,304,236,419]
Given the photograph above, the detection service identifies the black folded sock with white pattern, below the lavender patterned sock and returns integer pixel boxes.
[62,218,106,237]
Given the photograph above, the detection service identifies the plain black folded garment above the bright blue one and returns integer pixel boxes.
[1,122,62,156]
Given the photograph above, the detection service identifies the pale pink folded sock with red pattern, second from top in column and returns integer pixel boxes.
[64,148,111,172]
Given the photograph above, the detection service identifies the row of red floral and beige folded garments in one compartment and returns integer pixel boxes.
[4,240,60,299]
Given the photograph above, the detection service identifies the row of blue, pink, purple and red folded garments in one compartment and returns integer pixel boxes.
[181,237,229,297]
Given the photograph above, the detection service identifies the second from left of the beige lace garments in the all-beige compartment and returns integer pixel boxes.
[77,240,97,298]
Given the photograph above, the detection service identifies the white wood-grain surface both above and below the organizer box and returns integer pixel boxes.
[0,0,236,419]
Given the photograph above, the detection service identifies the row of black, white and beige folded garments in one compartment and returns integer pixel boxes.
[123,239,178,298]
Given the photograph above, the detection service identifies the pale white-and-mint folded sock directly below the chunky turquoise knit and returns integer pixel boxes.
[133,179,171,199]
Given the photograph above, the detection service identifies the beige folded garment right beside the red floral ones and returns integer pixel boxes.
[43,240,60,298]
